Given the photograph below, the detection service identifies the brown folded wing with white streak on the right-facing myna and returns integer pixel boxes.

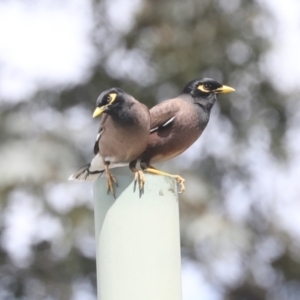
[150,99,180,133]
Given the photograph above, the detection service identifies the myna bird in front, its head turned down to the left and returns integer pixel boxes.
[69,87,150,195]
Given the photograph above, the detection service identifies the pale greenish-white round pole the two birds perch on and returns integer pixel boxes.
[94,168,181,300]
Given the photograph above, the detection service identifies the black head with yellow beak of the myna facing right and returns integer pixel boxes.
[182,78,234,98]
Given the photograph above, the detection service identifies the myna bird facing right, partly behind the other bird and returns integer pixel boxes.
[139,78,234,193]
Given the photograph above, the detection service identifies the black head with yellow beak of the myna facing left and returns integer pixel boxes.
[93,87,125,118]
